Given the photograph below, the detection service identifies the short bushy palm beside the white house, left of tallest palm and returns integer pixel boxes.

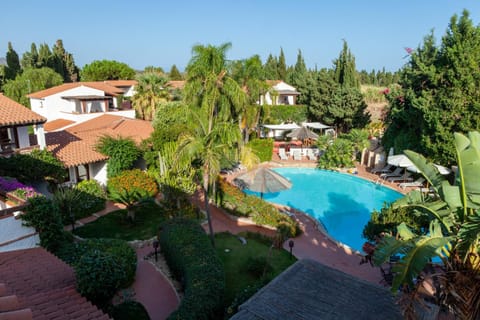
[132,72,170,121]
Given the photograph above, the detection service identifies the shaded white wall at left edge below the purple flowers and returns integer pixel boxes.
[0,216,40,252]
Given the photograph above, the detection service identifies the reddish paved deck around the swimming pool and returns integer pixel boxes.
[211,159,408,285]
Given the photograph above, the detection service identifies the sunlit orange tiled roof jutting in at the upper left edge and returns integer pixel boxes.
[0,93,47,126]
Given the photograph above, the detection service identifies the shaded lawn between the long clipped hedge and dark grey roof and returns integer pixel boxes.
[215,233,296,306]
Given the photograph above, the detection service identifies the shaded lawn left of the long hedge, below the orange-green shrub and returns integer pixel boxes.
[75,201,166,241]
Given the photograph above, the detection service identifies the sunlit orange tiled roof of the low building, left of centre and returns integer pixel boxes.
[41,114,153,167]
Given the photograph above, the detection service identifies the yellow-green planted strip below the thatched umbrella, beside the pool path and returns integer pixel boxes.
[218,181,301,238]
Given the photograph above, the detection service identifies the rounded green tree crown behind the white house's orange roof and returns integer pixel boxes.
[80,60,135,81]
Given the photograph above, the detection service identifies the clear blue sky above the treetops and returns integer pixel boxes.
[0,0,480,71]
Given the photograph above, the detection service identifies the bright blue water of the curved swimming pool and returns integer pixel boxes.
[249,168,403,251]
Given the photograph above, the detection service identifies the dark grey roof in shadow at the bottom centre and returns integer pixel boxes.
[231,259,403,320]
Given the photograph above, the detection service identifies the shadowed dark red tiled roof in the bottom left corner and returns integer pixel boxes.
[0,248,110,320]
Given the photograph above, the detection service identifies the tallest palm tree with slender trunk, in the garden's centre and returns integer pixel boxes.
[178,43,246,244]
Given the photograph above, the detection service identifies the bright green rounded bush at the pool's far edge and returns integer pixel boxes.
[318,138,354,169]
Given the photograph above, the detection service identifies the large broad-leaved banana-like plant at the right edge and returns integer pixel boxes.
[373,131,480,319]
